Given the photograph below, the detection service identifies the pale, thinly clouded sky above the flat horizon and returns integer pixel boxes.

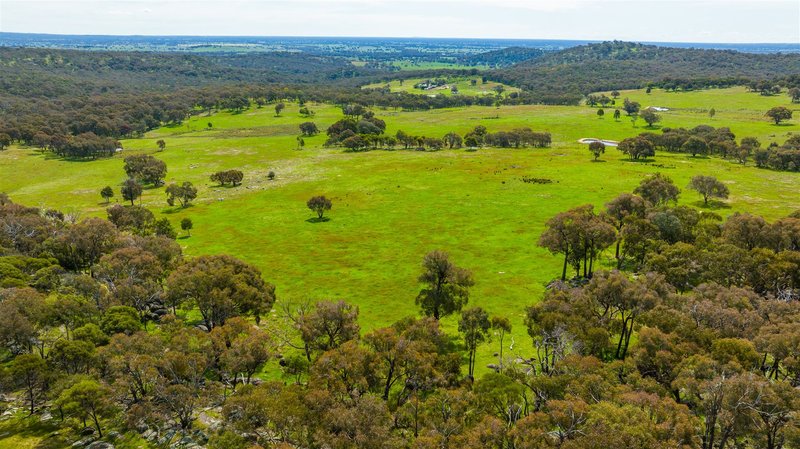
[0,0,800,43]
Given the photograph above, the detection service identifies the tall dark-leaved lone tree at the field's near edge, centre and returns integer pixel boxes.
[416,250,475,320]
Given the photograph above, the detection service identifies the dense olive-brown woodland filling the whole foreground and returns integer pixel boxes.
[0,189,800,449]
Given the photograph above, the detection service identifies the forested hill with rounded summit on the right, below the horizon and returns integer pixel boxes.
[492,42,800,94]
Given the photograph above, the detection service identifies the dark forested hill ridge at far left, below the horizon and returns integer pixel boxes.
[0,47,376,98]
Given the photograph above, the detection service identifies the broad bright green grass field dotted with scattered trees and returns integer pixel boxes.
[0,86,800,376]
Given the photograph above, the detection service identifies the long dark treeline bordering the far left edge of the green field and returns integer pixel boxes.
[0,86,568,157]
